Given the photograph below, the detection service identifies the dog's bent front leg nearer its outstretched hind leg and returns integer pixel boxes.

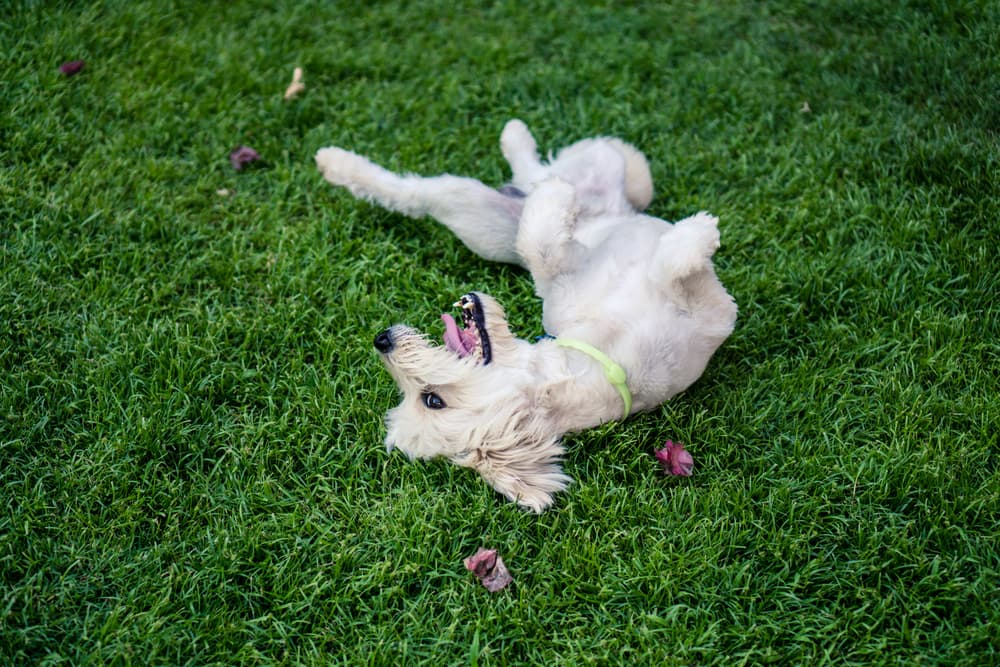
[517,178,584,293]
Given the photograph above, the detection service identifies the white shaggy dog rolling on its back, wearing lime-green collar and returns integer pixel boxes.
[316,120,736,512]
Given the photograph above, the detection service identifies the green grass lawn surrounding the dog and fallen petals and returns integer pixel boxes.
[0,0,1000,666]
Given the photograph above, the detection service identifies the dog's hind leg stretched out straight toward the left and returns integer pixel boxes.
[316,147,524,264]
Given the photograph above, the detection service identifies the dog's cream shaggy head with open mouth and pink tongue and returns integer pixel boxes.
[375,293,569,511]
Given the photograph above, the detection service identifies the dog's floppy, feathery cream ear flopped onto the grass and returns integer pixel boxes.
[452,433,573,512]
